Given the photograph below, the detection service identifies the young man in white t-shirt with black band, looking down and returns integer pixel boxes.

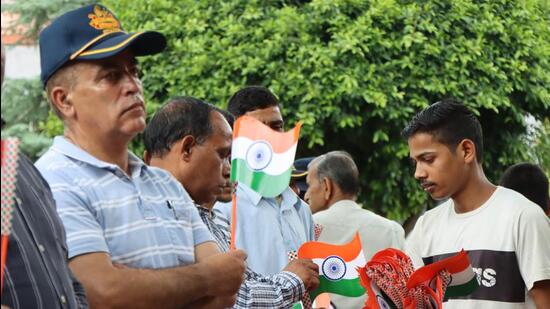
[403,100,550,309]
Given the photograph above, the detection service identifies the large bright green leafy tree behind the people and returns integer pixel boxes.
[100,0,550,220]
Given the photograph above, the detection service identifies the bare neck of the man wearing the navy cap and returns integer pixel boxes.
[64,126,131,175]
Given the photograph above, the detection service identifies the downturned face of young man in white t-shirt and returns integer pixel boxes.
[408,133,465,200]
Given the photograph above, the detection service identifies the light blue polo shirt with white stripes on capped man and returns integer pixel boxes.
[35,137,213,268]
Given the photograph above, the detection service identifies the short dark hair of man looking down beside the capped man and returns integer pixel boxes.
[143,97,218,157]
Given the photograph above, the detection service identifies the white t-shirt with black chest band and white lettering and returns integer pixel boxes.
[406,187,550,309]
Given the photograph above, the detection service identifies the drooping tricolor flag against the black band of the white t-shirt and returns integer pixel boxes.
[407,250,479,299]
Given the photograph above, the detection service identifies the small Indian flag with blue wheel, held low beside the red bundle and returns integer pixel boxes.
[298,234,365,299]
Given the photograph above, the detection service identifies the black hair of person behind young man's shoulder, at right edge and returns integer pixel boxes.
[499,163,549,213]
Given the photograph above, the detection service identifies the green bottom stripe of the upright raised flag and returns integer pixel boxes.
[231,159,292,197]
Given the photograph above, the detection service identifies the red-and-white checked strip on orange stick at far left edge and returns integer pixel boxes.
[0,138,19,290]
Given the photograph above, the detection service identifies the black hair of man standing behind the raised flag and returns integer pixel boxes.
[227,86,279,118]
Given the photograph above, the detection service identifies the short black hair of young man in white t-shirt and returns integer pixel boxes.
[401,99,483,163]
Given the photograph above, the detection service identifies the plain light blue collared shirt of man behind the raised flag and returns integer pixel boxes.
[215,183,314,275]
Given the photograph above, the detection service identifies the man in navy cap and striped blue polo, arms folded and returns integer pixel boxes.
[36,5,246,308]
